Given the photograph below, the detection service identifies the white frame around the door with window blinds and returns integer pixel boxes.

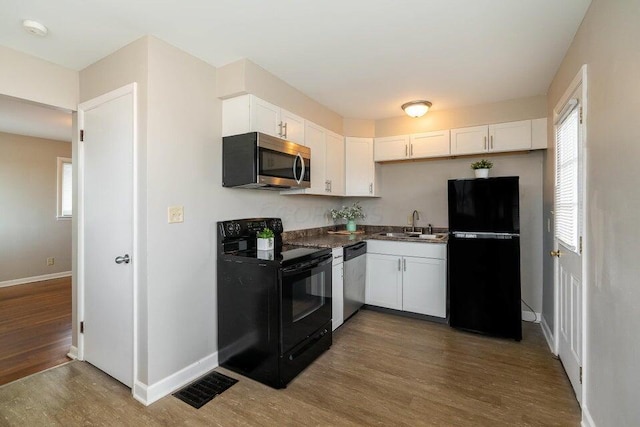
[553,64,589,406]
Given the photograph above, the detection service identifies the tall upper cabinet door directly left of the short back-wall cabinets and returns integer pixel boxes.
[345,137,375,196]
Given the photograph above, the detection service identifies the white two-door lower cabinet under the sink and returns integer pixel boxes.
[365,240,447,318]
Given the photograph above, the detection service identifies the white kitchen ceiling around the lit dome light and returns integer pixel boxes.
[0,0,591,119]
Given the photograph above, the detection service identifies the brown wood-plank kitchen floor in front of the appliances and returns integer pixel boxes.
[0,310,580,426]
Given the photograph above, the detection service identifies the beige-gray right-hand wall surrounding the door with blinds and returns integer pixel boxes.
[544,0,640,426]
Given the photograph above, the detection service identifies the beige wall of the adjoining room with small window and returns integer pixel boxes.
[0,133,71,282]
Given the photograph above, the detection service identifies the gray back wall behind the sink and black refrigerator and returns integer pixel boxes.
[351,151,544,320]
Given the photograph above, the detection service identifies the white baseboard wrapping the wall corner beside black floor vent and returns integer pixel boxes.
[133,352,218,406]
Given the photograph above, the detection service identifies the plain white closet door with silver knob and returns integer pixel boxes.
[79,86,136,387]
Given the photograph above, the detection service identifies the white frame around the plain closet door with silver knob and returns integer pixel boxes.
[76,82,140,393]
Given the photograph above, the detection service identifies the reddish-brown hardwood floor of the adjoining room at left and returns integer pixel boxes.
[0,277,71,385]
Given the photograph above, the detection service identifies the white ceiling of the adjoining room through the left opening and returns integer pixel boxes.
[0,96,72,142]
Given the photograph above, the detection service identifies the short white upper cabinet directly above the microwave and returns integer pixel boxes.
[222,95,305,144]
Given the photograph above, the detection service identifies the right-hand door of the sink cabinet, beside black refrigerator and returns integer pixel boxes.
[402,257,447,318]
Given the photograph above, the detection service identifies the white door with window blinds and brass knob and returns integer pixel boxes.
[551,81,584,402]
